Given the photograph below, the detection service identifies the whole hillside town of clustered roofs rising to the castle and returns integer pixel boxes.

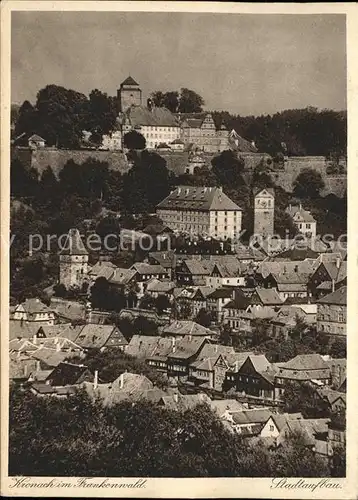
[9,65,347,475]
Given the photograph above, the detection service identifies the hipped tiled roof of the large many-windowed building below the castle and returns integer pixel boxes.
[157,186,241,211]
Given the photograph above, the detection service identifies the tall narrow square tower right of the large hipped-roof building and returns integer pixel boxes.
[254,188,275,237]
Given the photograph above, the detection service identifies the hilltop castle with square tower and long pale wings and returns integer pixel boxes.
[102,76,230,153]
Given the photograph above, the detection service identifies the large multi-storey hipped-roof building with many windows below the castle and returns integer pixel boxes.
[157,186,242,239]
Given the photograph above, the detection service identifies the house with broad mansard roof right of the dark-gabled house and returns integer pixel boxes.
[275,354,331,399]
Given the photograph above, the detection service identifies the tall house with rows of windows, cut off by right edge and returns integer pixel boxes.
[317,286,347,338]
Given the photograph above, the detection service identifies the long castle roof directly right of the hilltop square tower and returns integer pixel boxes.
[125,106,179,127]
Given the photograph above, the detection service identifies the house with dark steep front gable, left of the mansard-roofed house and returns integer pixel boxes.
[236,354,276,399]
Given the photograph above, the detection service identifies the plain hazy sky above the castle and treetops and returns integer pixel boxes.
[11,12,346,116]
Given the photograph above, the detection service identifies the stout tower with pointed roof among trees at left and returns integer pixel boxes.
[59,229,88,289]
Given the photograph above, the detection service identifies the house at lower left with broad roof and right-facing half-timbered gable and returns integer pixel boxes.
[75,323,128,351]
